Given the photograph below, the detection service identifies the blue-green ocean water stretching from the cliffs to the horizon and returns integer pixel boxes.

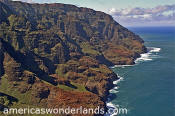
[107,27,175,116]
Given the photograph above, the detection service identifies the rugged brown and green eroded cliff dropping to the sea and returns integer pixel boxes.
[0,0,146,115]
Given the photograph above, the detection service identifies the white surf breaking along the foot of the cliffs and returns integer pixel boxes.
[105,47,161,116]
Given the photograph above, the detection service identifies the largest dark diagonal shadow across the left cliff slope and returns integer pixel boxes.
[2,40,57,85]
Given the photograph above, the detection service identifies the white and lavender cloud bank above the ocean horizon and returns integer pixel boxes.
[109,4,175,25]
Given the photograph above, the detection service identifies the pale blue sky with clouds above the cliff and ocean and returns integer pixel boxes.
[14,0,175,26]
